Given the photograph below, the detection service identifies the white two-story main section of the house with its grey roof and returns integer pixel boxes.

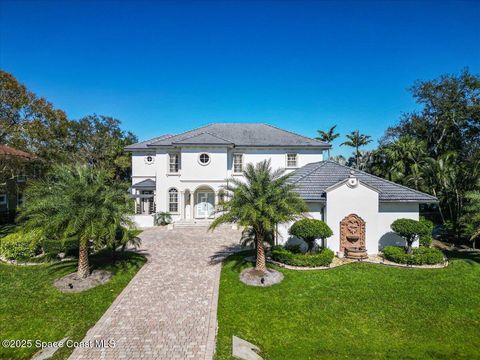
[126,124,330,226]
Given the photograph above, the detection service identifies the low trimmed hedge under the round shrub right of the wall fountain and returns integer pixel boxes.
[383,246,444,265]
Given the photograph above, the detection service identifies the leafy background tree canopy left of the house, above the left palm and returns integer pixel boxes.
[0,70,137,179]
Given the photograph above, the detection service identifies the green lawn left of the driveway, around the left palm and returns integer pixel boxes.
[0,252,145,359]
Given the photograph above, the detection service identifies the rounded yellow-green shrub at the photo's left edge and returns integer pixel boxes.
[0,231,40,260]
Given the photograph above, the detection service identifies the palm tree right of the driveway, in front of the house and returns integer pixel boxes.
[209,160,308,273]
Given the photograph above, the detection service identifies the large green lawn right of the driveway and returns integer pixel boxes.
[216,250,480,360]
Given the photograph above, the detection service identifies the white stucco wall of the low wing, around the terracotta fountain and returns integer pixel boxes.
[278,182,419,254]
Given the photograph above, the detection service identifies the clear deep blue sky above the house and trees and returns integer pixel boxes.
[0,0,480,154]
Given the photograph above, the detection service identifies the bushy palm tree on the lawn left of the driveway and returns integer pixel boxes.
[19,165,131,278]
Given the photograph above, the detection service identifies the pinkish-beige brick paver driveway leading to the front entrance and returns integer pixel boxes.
[70,227,240,360]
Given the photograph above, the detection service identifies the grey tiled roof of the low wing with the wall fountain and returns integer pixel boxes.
[290,161,438,203]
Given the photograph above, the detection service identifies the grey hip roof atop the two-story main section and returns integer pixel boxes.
[126,123,331,150]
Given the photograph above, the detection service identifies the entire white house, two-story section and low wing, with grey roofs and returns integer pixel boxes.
[126,124,436,254]
